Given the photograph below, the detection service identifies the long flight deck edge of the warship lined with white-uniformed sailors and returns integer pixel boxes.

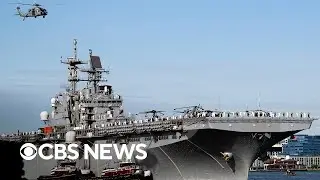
[0,111,315,141]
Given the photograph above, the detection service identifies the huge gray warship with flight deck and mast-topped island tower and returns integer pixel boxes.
[1,40,317,180]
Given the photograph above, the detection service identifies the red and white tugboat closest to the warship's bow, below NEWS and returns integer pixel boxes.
[101,161,153,180]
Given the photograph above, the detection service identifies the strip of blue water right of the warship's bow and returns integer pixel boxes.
[249,171,320,180]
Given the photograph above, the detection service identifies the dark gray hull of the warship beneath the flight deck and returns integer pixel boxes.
[24,129,296,180]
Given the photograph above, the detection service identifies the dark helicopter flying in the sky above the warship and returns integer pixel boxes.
[10,3,48,21]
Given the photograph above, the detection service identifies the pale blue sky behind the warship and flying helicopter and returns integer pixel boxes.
[0,0,320,135]
